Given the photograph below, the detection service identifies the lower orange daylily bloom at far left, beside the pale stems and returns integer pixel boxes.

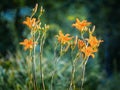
[20,39,34,50]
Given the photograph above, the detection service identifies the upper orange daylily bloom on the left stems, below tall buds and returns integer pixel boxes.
[23,17,36,29]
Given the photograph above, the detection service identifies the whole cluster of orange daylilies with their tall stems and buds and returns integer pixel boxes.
[20,4,103,90]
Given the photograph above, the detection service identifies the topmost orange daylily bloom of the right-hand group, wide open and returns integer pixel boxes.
[72,18,91,32]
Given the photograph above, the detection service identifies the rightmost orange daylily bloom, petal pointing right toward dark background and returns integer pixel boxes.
[87,35,103,48]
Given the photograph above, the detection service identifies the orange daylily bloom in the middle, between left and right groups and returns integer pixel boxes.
[57,31,73,44]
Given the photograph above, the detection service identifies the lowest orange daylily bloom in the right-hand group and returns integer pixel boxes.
[81,46,97,58]
